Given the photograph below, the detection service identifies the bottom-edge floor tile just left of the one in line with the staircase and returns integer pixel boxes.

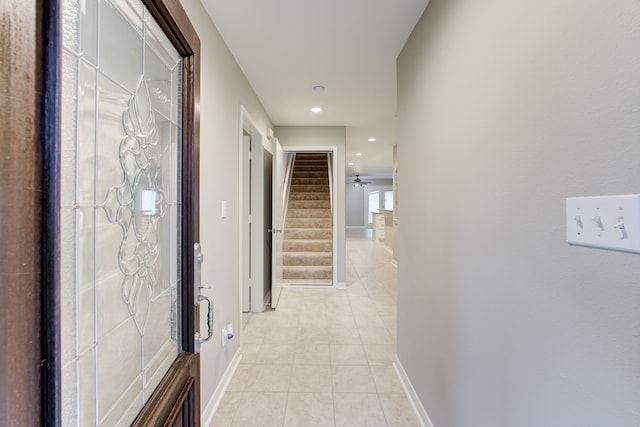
[231,392,287,427]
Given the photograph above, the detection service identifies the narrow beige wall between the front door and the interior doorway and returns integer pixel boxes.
[181,0,272,420]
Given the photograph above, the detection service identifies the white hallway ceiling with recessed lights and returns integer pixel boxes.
[201,0,429,178]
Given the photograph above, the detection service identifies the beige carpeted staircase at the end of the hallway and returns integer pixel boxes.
[283,153,333,285]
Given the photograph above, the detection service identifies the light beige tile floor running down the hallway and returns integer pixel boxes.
[212,230,420,427]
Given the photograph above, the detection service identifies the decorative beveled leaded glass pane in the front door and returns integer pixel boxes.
[61,0,182,426]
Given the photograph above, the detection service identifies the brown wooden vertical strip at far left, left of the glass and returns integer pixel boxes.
[0,0,60,425]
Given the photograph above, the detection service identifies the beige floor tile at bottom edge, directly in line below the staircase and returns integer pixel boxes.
[284,393,335,427]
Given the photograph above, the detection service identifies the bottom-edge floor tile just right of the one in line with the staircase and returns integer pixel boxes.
[333,393,387,427]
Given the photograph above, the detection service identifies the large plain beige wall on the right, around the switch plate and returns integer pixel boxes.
[398,0,640,427]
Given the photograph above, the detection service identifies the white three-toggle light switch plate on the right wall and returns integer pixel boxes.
[567,194,640,253]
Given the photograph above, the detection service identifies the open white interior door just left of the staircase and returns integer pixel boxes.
[271,138,286,308]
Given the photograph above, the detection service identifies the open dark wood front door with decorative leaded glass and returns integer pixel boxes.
[0,0,200,425]
